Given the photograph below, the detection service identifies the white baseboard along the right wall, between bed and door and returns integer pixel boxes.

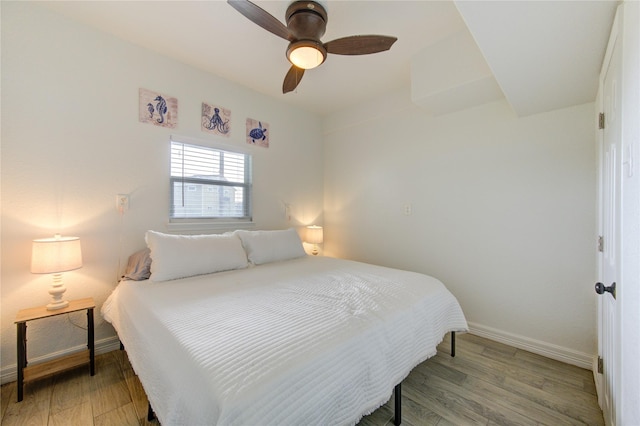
[469,322,597,371]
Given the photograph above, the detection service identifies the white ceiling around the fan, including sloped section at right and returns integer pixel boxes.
[37,0,617,115]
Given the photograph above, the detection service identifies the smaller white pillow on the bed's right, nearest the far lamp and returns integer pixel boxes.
[235,228,307,265]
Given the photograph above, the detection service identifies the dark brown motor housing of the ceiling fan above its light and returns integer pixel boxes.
[286,1,328,43]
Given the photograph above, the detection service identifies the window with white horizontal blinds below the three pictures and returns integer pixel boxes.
[170,141,251,220]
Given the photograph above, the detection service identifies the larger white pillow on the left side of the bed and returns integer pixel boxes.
[145,231,249,281]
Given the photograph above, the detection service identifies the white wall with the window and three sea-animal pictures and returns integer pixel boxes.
[0,2,323,378]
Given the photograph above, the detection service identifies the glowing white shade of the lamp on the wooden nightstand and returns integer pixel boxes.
[31,235,82,274]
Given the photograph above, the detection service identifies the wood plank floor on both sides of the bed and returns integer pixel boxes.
[0,334,604,426]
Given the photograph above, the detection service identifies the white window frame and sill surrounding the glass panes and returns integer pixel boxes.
[167,135,253,226]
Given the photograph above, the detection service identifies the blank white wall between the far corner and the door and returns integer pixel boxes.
[324,92,596,367]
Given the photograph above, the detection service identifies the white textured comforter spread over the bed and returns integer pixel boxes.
[102,257,467,426]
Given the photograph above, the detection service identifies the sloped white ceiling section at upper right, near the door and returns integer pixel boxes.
[458,1,618,116]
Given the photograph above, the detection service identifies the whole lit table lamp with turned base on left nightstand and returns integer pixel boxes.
[31,234,82,311]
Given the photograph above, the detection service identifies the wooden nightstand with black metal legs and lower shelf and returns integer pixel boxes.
[15,297,96,402]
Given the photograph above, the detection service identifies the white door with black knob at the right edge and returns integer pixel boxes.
[596,17,622,426]
